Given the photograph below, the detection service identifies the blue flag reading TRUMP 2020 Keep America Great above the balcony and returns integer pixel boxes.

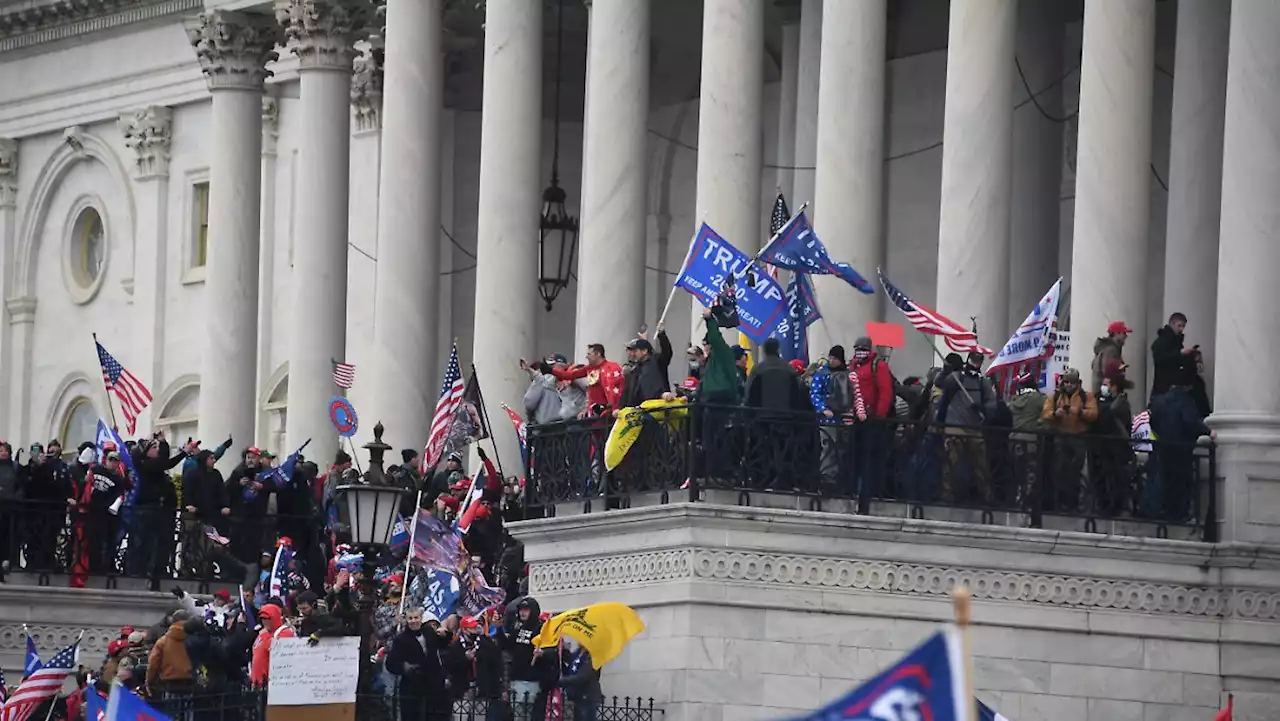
[676,223,787,343]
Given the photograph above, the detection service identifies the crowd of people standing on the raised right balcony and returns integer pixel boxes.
[521,309,1211,520]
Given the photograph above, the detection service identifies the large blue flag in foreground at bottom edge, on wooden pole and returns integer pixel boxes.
[773,628,974,721]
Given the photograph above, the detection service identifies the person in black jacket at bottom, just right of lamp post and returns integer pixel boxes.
[387,608,453,721]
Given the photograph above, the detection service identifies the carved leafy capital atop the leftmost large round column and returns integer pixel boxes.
[187,10,284,91]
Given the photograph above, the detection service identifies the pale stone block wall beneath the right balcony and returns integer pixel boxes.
[511,503,1280,721]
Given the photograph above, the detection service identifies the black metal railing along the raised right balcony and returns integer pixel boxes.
[525,405,1216,540]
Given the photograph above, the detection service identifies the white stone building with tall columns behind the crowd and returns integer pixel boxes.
[0,0,1280,721]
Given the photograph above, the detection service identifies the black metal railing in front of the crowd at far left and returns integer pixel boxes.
[0,501,324,590]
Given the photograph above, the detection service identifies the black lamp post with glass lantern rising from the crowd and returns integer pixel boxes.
[335,423,404,717]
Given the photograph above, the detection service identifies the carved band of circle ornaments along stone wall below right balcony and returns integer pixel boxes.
[529,548,1280,621]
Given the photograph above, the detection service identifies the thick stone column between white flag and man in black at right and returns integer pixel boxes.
[1070,0,1156,394]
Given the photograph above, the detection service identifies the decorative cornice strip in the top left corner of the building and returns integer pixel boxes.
[0,0,204,53]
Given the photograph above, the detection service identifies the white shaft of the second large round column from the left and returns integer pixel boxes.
[285,65,353,462]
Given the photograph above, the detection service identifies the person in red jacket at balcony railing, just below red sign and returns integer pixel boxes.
[849,336,893,514]
